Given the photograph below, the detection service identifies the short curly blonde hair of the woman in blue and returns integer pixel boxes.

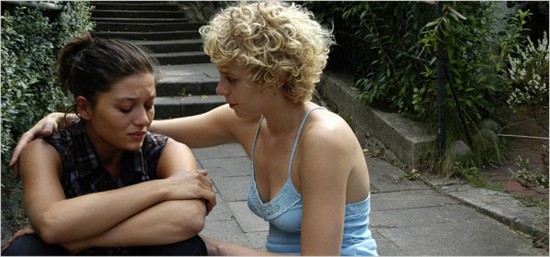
[199,1,334,103]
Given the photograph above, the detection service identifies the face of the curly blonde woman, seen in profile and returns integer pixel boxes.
[216,63,269,118]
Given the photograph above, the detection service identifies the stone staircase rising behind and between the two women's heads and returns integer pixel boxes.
[92,1,225,119]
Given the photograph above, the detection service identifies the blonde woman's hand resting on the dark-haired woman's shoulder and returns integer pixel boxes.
[9,112,74,178]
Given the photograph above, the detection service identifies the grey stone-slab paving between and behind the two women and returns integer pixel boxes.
[164,65,548,256]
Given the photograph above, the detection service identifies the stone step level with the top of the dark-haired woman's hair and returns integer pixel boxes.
[92,31,200,41]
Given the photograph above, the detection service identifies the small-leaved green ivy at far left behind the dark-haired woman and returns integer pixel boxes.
[1,1,93,180]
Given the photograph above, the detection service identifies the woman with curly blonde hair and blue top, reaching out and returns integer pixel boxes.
[9,1,377,255]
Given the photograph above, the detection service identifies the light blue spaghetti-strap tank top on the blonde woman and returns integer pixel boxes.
[247,107,378,256]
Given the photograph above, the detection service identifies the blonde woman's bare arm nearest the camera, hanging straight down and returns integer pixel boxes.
[298,116,354,256]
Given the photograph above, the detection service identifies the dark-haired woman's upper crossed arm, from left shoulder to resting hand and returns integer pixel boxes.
[21,140,215,243]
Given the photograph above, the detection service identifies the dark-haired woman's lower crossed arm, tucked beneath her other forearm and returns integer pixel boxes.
[61,139,216,252]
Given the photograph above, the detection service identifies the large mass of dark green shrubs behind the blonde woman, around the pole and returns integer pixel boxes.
[306,1,536,175]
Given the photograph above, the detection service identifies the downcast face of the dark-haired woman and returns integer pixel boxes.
[87,73,156,151]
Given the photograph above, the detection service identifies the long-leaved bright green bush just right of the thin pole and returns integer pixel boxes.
[420,2,529,124]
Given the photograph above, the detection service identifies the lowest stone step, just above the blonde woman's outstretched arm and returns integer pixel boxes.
[155,95,226,119]
